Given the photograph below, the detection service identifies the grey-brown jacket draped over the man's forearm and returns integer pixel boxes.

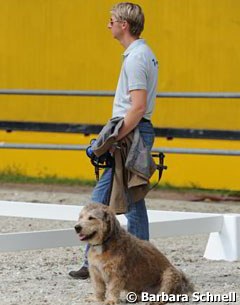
[92,117,157,214]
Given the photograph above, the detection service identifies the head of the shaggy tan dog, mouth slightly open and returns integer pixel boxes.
[74,203,120,245]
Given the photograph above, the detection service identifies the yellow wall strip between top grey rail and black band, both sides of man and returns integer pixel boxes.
[0,96,240,130]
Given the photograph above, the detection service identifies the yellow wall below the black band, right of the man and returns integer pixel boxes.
[154,138,240,190]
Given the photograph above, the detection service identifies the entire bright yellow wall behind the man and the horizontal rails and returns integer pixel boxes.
[0,0,240,189]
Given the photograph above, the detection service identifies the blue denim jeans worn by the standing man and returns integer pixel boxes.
[83,122,154,267]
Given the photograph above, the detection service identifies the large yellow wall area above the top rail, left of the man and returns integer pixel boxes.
[0,0,121,90]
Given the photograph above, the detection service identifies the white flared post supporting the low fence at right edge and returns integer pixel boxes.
[204,214,240,262]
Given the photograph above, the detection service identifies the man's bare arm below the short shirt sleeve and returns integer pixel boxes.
[117,89,147,141]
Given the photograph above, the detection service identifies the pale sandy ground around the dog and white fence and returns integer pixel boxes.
[0,185,240,305]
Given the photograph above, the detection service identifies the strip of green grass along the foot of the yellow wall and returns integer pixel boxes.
[0,169,240,197]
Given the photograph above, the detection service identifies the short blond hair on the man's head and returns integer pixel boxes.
[110,2,144,37]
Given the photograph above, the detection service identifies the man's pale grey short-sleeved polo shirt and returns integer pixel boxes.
[112,39,158,120]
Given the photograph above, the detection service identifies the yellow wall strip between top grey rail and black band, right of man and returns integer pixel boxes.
[152,98,240,131]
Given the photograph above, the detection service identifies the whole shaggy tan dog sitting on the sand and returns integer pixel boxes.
[75,204,193,305]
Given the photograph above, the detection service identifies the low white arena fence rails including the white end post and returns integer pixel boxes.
[0,201,240,261]
